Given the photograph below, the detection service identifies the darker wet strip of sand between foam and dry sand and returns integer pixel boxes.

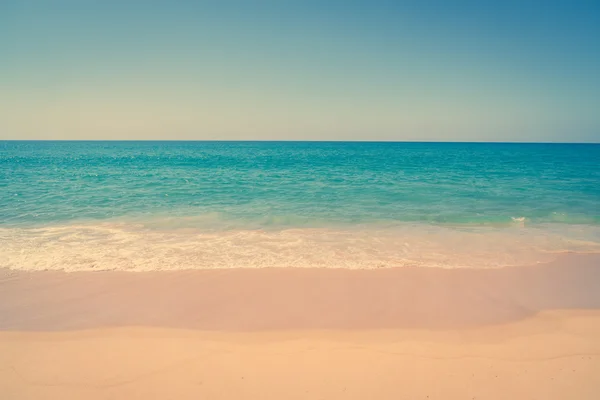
[0,255,600,332]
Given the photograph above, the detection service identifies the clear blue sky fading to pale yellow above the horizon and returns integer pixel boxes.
[0,0,600,142]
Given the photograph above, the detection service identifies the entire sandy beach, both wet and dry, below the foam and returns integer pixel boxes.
[0,255,600,400]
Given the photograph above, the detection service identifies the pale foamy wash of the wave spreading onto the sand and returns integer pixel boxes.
[0,223,600,271]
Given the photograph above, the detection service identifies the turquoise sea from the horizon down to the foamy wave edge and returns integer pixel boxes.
[0,141,600,271]
